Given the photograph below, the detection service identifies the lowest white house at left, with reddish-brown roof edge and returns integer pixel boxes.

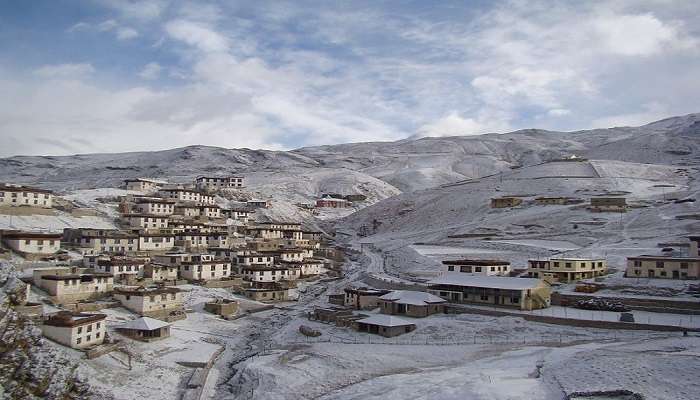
[41,311,107,349]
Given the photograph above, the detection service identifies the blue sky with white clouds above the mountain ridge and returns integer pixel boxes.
[0,0,700,156]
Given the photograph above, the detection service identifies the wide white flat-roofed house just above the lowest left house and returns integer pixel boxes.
[39,273,114,303]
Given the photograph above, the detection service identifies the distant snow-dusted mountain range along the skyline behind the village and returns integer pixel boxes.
[0,114,700,200]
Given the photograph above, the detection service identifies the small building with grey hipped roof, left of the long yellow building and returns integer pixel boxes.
[379,290,447,317]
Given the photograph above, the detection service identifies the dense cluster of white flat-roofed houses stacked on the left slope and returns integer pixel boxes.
[2,176,335,349]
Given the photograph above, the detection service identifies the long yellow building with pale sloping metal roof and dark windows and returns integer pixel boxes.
[428,272,551,310]
